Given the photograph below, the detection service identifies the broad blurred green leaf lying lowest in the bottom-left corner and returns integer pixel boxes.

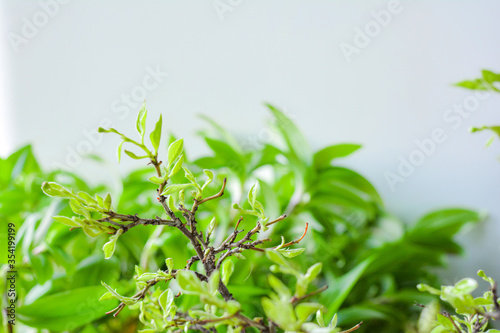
[17,286,117,331]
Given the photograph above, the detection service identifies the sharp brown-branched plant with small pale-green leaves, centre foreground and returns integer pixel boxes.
[39,105,364,333]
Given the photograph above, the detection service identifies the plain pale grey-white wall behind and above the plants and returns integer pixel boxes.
[0,0,500,283]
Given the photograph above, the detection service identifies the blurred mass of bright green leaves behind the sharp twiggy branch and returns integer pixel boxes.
[0,105,480,333]
